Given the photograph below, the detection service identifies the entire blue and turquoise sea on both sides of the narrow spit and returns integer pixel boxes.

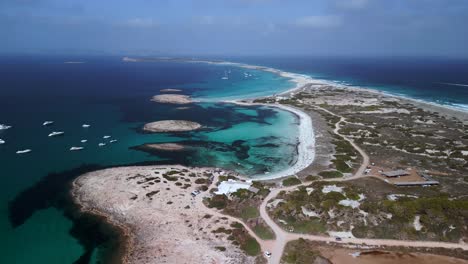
[0,56,468,263]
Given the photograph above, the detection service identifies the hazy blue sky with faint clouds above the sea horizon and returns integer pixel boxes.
[0,0,468,57]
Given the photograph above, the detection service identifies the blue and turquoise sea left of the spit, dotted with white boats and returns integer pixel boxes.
[0,58,297,263]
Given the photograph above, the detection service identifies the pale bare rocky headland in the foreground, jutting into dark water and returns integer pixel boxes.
[71,166,254,263]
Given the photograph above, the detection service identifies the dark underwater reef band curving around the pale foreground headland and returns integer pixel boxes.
[8,161,167,264]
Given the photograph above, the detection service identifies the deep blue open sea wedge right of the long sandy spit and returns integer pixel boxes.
[232,57,468,111]
